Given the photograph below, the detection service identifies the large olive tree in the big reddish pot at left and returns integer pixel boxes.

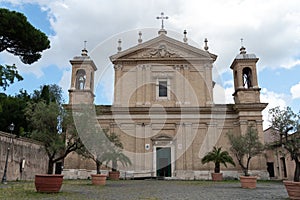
[25,85,83,192]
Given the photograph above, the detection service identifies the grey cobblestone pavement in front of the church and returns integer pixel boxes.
[62,180,288,200]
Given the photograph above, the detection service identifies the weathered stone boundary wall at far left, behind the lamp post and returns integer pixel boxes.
[0,132,48,181]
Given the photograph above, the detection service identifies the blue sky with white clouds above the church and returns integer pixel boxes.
[0,0,300,128]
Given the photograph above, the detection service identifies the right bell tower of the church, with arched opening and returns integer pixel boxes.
[230,46,260,104]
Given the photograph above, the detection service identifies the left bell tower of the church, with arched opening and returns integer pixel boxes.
[69,48,97,104]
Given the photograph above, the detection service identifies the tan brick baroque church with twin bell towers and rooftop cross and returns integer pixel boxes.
[63,16,268,179]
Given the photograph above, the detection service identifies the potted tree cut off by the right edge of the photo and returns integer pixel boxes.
[269,107,300,199]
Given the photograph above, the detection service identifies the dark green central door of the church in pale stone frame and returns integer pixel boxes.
[156,147,172,177]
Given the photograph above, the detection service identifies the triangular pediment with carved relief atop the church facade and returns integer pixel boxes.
[110,34,217,62]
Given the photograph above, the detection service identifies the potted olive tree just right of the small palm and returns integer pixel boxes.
[228,126,264,188]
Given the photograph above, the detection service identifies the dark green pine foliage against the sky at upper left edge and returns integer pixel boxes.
[0,8,50,90]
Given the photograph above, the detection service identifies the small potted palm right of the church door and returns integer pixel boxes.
[201,146,235,181]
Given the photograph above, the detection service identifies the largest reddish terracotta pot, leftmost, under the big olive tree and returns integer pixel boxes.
[34,174,64,193]
